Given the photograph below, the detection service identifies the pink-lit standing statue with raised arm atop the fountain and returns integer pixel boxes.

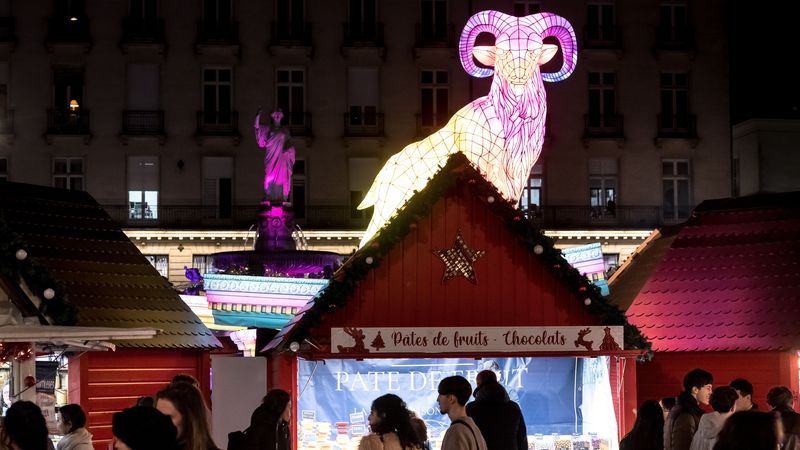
[255,109,295,202]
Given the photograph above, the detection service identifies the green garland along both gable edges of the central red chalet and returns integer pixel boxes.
[286,154,653,360]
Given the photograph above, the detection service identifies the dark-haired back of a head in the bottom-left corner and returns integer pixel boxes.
[0,400,50,450]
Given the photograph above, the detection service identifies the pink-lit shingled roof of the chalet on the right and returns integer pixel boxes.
[627,192,800,352]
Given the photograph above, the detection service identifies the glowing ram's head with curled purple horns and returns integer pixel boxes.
[459,11,578,94]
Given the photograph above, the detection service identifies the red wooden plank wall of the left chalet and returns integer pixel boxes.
[68,349,210,450]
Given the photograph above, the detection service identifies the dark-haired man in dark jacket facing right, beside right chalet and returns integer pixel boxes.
[664,369,714,450]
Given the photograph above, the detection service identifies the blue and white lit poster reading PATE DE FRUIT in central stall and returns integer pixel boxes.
[297,357,616,449]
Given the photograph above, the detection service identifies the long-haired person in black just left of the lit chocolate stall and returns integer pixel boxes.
[244,389,292,450]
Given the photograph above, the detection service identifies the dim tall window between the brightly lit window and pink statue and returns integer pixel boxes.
[203,156,233,219]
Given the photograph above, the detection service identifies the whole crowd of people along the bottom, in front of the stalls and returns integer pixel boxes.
[6,369,800,450]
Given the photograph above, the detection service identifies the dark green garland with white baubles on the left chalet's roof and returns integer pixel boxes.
[0,212,78,325]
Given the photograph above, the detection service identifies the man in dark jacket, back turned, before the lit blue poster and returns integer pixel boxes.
[467,370,528,450]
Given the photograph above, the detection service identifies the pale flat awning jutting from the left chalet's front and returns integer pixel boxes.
[0,325,159,351]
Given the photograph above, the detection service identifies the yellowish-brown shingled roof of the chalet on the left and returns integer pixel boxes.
[0,182,221,349]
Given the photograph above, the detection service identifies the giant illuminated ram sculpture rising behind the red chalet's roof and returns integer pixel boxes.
[358,11,578,246]
